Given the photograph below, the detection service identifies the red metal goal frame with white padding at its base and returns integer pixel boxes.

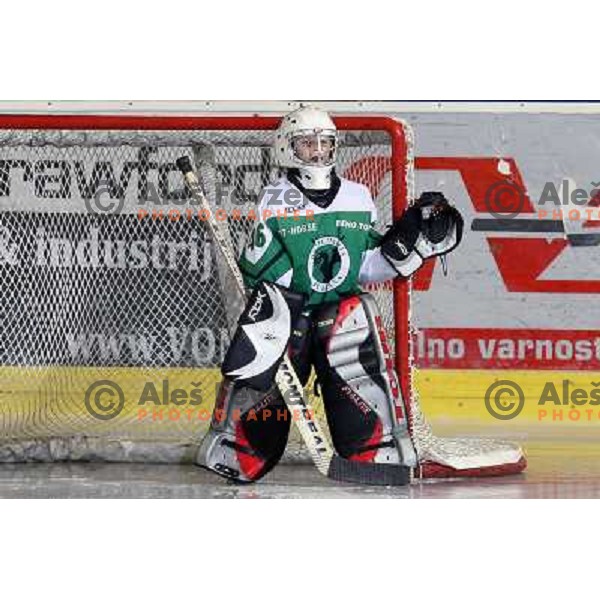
[0,111,527,477]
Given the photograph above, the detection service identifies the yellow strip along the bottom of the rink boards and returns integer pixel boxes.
[0,366,600,444]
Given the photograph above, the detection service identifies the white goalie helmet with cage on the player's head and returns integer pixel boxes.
[274,106,338,190]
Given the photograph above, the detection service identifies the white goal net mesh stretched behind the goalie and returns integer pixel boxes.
[0,131,393,460]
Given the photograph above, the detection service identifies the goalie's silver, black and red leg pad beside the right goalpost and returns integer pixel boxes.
[314,294,417,467]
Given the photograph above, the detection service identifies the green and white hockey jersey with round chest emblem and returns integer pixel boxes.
[240,173,397,306]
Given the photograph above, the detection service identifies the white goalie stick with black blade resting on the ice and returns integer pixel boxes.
[177,156,411,485]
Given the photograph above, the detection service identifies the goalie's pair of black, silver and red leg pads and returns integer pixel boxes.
[197,294,410,482]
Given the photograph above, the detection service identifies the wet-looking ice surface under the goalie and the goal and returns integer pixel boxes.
[0,435,600,499]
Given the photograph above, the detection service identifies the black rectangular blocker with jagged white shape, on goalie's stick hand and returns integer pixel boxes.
[221,281,305,391]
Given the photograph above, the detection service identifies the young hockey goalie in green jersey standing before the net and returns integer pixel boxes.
[197,107,463,482]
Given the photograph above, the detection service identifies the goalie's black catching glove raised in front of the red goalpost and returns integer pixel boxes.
[381,192,464,277]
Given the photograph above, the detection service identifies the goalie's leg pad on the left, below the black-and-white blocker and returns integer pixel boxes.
[196,317,310,483]
